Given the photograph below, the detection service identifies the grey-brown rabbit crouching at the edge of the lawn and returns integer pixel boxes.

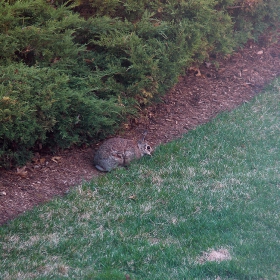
[93,138,152,172]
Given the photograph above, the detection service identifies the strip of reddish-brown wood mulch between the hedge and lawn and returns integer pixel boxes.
[0,38,280,225]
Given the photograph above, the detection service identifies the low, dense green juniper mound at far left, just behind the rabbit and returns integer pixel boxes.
[0,64,123,167]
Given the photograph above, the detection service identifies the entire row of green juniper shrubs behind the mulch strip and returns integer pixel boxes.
[0,0,280,166]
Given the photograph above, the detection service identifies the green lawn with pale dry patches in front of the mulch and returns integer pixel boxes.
[0,77,280,280]
